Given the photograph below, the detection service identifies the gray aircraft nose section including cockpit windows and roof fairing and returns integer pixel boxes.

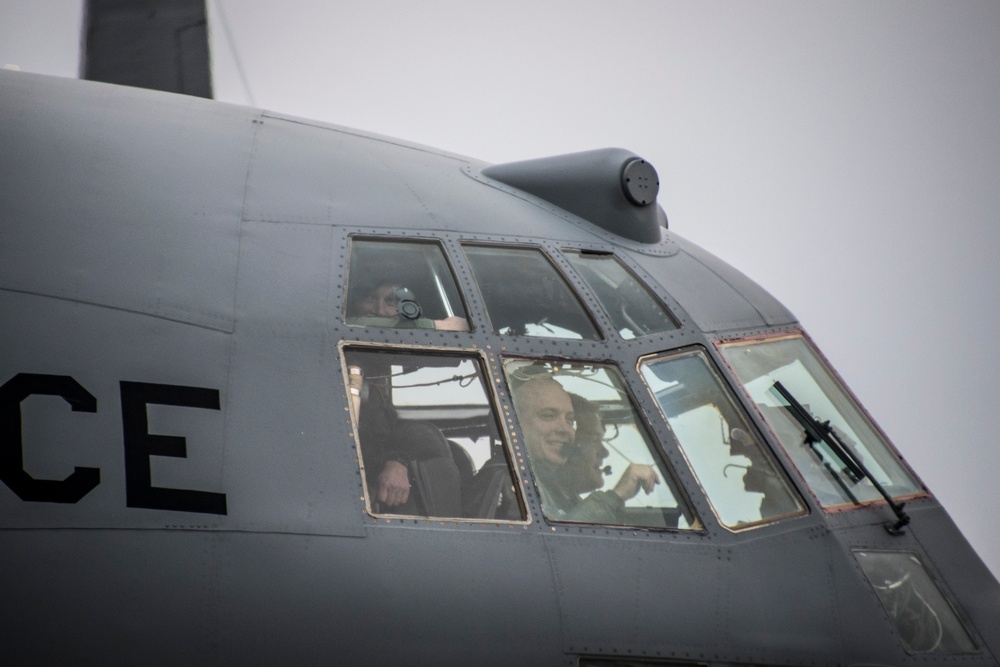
[0,71,1000,666]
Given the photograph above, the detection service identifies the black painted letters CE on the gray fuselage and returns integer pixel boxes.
[0,373,226,514]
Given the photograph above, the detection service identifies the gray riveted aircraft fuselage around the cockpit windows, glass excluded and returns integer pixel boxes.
[0,71,1000,665]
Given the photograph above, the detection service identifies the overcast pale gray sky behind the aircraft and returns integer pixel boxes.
[0,0,1000,573]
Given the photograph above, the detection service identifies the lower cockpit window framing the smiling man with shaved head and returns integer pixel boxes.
[504,359,699,528]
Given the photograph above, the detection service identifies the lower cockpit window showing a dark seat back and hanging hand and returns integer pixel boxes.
[342,346,527,521]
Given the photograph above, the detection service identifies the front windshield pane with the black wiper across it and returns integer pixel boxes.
[719,335,923,507]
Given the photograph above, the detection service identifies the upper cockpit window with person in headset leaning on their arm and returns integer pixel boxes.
[345,239,469,331]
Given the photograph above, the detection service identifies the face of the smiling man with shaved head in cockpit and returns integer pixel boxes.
[516,378,576,465]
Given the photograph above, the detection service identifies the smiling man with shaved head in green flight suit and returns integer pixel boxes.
[514,378,660,524]
